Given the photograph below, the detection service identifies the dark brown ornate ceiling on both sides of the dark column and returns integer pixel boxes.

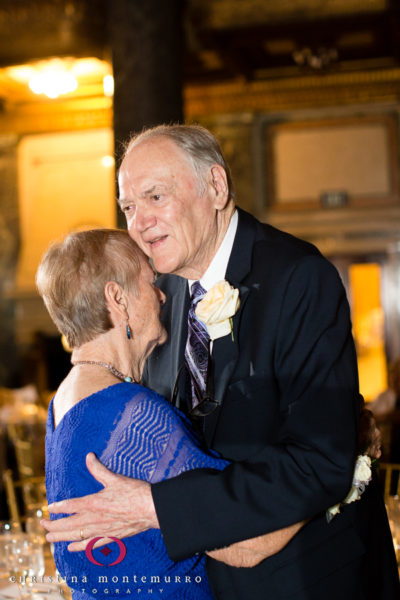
[0,0,400,84]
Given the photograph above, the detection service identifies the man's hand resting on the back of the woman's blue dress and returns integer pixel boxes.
[41,453,159,552]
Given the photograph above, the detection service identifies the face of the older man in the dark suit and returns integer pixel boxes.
[118,137,225,279]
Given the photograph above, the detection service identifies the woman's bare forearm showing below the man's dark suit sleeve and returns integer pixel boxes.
[206,521,306,567]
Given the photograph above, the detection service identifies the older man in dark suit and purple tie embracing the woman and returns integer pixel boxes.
[42,126,396,600]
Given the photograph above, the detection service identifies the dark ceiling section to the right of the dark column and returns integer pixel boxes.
[186,0,400,83]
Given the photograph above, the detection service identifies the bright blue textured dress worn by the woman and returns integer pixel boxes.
[46,383,228,600]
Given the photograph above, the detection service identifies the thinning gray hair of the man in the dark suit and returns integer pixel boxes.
[122,124,235,199]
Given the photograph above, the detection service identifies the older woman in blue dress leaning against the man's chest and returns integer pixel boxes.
[37,229,300,600]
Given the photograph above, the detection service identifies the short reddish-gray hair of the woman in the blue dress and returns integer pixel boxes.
[36,229,144,348]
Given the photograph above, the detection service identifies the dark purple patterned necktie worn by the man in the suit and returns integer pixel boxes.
[185,281,210,407]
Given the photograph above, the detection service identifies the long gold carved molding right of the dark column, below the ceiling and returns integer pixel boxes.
[184,68,400,119]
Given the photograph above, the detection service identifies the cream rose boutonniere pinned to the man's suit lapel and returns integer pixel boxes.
[195,280,240,340]
